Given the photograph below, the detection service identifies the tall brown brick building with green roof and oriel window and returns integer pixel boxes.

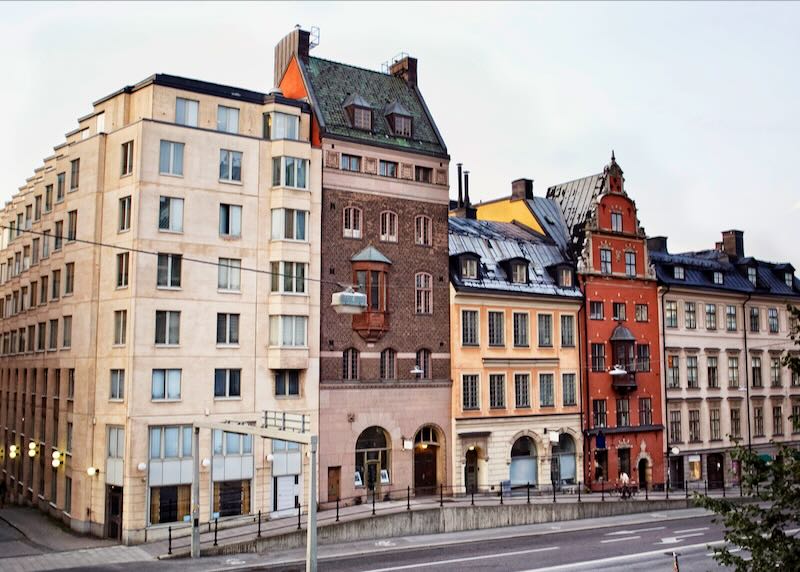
[275,29,451,503]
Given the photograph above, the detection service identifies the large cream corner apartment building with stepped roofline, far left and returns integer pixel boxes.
[0,75,321,543]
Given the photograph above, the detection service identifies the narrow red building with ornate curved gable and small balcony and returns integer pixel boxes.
[547,153,665,490]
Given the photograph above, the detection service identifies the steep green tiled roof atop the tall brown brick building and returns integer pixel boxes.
[304,58,447,156]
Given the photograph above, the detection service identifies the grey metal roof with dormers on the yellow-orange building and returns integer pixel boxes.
[448,217,581,299]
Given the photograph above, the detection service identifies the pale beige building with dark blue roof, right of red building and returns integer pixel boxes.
[649,231,800,489]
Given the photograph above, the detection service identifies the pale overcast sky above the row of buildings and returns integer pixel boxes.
[0,2,800,269]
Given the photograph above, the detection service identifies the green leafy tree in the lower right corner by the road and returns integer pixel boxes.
[696,306,800,571]
